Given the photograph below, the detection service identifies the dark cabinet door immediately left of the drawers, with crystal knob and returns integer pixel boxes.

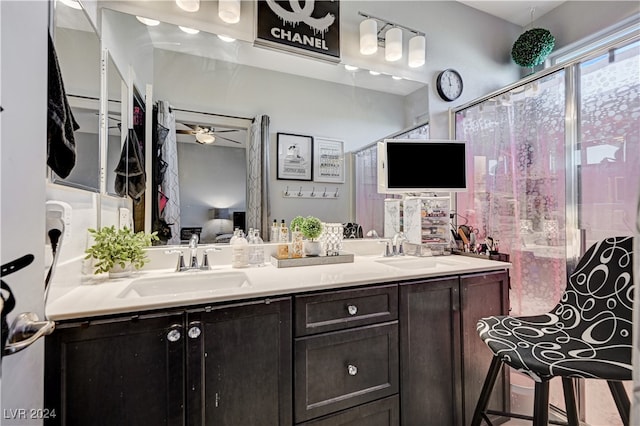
[187,298,292,426]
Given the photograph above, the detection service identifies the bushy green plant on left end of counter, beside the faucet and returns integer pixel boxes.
[85,226,158,278]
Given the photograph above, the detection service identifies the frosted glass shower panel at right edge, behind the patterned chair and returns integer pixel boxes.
[578,41,640,426]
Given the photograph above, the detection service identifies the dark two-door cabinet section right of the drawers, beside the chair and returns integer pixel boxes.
[399,271,509,426]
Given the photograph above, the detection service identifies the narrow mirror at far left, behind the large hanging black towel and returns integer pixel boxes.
[50,1,100,192]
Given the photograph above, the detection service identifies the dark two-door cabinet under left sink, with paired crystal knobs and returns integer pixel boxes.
[45,298,292,426]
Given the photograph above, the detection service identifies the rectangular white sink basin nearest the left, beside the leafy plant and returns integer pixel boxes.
[118,271,251,299]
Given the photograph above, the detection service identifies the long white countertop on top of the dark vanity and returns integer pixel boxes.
[46,255,511,321]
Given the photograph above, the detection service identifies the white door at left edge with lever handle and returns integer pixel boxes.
[0,0,49,426]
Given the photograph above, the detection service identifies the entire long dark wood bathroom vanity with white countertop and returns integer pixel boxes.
[45,251,510,426]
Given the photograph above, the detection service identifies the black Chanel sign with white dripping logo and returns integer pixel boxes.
[256,0,340,62]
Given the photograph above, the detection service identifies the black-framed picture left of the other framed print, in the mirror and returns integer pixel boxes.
[277,133,313,180]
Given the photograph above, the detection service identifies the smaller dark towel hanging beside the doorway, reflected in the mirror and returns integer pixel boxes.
[115,129,147,202]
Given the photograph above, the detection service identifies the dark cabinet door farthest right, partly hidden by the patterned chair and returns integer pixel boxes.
[460,271,510,424]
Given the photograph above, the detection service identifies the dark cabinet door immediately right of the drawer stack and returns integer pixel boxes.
[400,277,462,426]
